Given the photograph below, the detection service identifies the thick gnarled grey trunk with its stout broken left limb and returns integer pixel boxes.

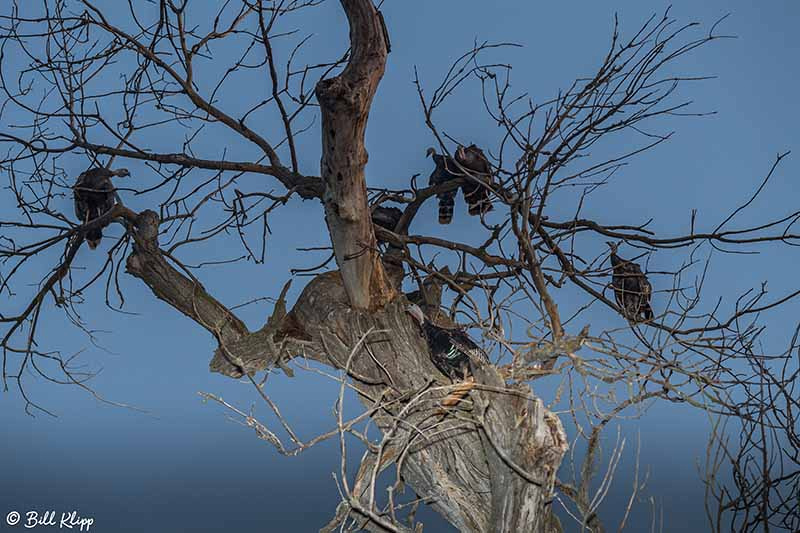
[123,211,567,533]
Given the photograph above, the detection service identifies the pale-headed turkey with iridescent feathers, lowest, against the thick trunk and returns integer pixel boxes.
[407,305,489,381]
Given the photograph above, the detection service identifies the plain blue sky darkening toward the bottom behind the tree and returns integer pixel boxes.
[0,0,800,533]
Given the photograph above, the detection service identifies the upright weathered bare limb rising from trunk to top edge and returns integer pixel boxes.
[316,0,393,309]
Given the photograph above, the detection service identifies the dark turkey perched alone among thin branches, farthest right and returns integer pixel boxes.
[606,242,653,322]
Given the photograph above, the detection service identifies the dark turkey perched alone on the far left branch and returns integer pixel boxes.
[72,168,130,250]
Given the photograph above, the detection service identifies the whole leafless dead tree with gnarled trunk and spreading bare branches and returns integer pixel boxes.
[0,0,800,532]
